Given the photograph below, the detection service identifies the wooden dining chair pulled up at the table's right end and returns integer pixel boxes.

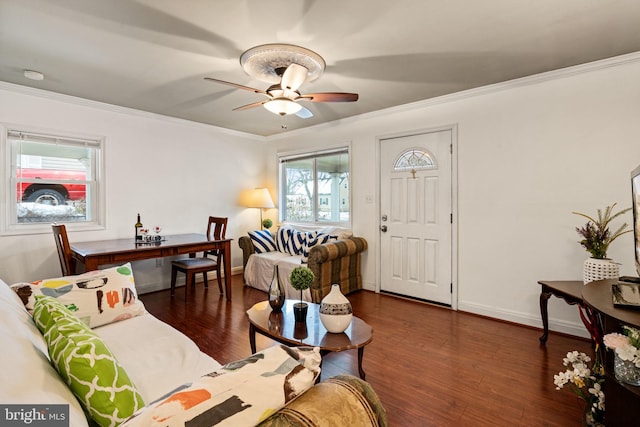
[171,216,227,301]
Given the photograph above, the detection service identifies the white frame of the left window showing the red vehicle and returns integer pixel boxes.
[0,123,106,235]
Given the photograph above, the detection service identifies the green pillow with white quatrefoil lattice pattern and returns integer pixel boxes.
[33,296,144,426]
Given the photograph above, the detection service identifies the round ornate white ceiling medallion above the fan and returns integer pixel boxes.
[240,43,326,83]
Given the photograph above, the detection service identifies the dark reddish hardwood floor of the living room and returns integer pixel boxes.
[140,275,593,427]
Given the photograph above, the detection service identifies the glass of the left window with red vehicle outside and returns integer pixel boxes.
[10,137,96,224]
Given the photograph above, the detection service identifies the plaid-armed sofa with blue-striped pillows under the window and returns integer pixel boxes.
[238,224,367,303]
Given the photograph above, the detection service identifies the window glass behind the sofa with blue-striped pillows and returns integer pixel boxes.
[280,148,351,224]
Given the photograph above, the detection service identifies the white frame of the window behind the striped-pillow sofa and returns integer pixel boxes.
[278,144,353,228]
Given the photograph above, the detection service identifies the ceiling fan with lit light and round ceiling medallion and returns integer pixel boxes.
[205,44,358,119]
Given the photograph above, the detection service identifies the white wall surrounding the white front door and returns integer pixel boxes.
[269,55,640,336]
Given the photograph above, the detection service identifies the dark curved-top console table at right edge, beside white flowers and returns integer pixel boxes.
[582,280,640,427]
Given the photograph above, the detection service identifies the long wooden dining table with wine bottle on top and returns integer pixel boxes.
[70,234,232,301]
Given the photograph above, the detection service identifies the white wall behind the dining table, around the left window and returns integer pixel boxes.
[0,84,268,292]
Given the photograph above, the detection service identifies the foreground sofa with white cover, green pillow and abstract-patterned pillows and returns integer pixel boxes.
[0,264,386,427]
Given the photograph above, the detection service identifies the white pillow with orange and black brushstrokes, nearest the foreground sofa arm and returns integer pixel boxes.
[122,345,321,427]
